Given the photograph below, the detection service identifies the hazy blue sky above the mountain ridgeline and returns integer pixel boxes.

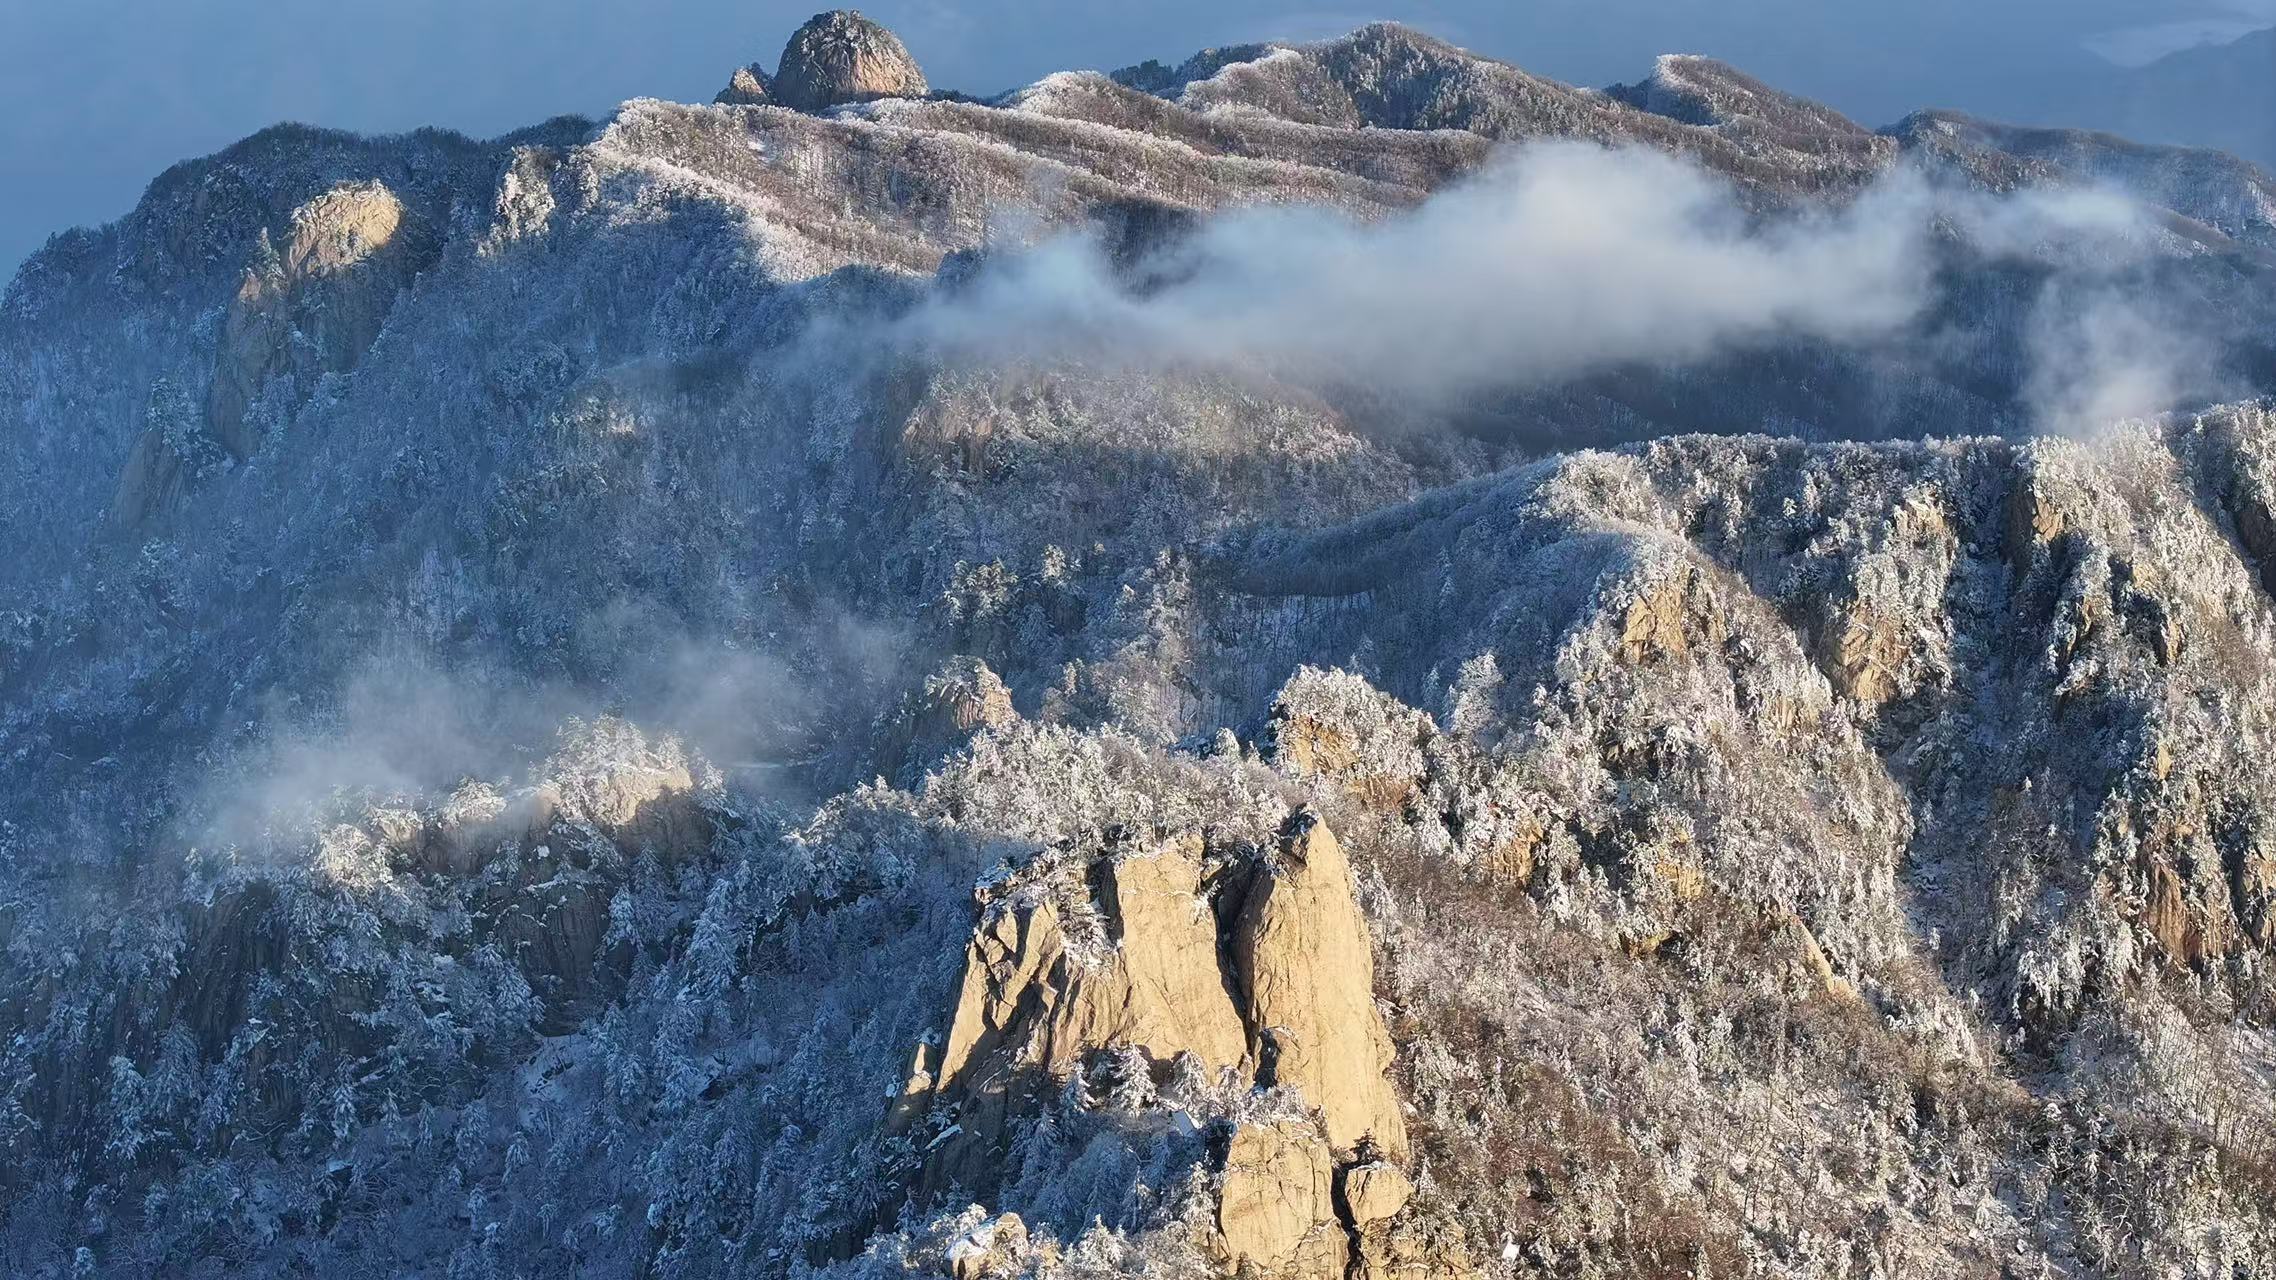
[0,0,2276,276]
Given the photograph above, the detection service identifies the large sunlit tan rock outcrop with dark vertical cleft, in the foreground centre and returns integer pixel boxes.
[910,811,1407,1275]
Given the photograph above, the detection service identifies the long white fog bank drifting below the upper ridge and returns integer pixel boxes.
[904,141,2192,433]
